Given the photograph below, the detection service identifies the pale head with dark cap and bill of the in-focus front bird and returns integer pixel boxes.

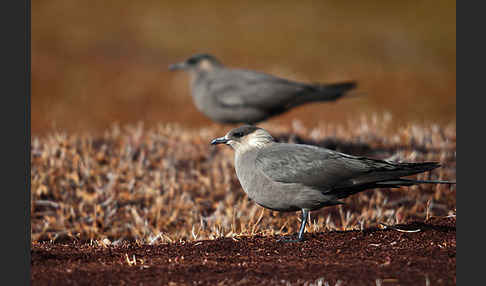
[211,125,274,153]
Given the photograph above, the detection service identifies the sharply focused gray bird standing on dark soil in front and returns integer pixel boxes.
[211,126,455,241]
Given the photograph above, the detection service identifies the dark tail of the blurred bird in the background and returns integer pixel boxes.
[291,81,357,107]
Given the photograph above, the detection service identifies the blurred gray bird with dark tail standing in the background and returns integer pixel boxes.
[169,54,356,124]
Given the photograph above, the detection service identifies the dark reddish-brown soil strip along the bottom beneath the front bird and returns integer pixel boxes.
[31,217,456,285]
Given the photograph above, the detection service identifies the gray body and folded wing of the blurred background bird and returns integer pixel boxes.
[206,69,309,109]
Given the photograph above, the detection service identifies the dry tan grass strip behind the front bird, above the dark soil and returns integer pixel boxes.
[31,116,456,243]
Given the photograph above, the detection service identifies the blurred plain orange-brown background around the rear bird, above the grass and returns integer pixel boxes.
[31,0,456,135]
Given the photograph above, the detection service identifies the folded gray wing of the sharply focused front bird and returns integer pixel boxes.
[256,143,402,189]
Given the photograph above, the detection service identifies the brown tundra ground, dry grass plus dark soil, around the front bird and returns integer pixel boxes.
[31,115,456,285]
